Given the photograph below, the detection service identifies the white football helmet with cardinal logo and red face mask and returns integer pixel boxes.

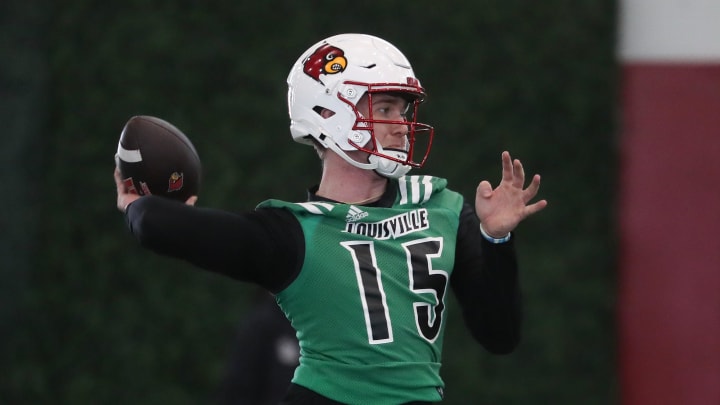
[287,34,434,178]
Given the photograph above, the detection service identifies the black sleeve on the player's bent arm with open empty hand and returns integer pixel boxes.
[450,203,521,354]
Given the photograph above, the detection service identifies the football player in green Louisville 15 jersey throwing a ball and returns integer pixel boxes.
[116,34,547,405]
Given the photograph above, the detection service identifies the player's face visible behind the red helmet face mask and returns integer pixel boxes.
[357,93,409,150]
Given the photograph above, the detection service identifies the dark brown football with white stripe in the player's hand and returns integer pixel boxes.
[115,115,202,202]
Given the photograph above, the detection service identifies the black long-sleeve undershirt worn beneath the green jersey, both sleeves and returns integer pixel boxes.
[126,191,521,354]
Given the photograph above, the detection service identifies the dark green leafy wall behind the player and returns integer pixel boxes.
[0,0,716,405]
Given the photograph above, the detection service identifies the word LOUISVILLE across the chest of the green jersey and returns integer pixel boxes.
[345,208,430,239]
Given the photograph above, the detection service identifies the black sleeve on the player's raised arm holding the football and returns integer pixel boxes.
[126,196,305,292]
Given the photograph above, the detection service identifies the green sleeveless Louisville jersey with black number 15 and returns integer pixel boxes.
[260,176,463,405]
